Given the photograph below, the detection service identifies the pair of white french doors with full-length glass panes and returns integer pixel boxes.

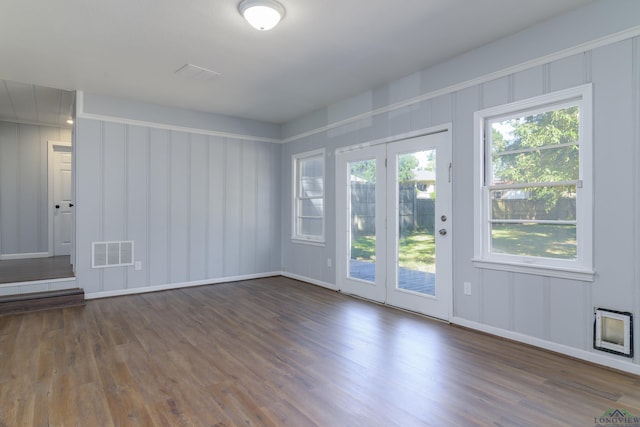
[336,132,452,320]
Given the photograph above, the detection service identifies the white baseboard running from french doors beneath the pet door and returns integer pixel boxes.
[451,317,640,375]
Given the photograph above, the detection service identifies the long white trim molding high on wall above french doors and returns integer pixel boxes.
[280,25,640,144]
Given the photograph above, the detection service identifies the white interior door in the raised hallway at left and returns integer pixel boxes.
[53,145,73,255]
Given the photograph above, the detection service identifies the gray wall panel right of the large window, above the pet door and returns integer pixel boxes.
[592,40,638,311]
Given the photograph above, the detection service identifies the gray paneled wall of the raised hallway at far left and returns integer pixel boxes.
[0,122,71,255]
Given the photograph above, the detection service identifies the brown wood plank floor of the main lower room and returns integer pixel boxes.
[0,277,640,427]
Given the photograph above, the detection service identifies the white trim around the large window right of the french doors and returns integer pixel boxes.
[473,84,595,281]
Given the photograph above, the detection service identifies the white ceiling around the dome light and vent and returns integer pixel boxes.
[0,0,592,125]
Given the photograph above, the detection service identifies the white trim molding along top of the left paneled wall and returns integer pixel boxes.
[76,90,282,143]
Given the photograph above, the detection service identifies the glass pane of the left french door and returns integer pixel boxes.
[349,159,376,282]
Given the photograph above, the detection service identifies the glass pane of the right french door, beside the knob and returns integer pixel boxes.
[396,149,436,296]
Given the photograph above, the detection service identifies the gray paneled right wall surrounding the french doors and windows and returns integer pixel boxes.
[282,1,640,370]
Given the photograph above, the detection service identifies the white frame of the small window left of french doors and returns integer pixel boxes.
[291,148,327,246]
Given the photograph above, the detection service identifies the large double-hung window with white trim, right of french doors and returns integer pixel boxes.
[475,85,593,280]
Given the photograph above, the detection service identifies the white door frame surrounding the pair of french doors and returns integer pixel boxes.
[335,123,453,321]
